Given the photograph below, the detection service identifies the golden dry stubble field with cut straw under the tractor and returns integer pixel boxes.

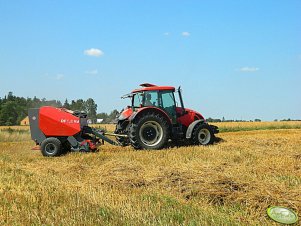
[0,122,301,225]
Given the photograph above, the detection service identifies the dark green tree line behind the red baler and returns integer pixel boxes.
[0,92,119,126]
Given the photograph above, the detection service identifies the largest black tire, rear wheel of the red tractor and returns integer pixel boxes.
[129,113,169,150]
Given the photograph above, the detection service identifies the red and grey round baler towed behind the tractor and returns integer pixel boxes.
[28,106,116,156]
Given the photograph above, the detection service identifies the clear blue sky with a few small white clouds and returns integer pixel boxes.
[0,0,301,120]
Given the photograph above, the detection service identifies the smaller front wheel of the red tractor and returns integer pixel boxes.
[192,123,215,145]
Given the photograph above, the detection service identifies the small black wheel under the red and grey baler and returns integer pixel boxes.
[41,137,63,157]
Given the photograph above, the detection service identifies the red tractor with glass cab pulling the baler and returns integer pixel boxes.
[115,83,219,149]
